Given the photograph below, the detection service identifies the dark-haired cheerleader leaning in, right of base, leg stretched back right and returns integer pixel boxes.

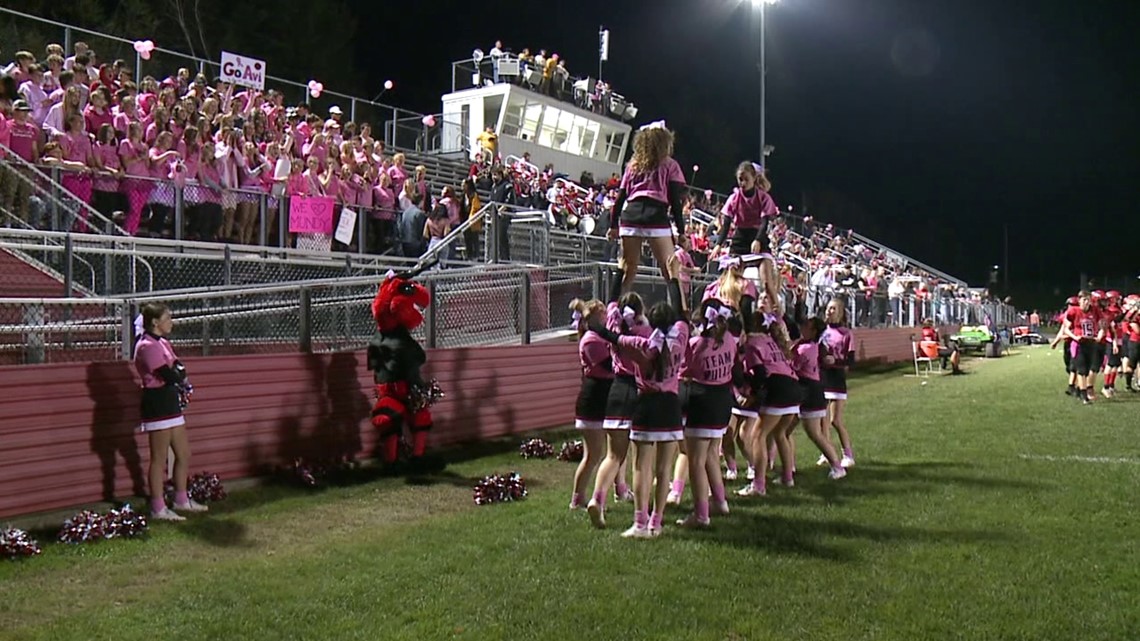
[788,317,847,480]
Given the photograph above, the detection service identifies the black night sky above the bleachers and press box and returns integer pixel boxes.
[351,0,1140,292]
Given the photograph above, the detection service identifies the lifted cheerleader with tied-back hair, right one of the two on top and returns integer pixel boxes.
[717,161,783,315]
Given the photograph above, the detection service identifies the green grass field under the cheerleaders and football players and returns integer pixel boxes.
[0,348,1140,641]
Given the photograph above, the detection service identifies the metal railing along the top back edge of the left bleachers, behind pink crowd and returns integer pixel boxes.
[0,7,424,145]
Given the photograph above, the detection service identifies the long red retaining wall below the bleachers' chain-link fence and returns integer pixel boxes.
[0,330,913,518]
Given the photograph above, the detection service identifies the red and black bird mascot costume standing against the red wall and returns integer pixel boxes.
[368,263,442,468]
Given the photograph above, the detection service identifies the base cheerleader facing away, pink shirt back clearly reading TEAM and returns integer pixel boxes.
[673,302,738,528]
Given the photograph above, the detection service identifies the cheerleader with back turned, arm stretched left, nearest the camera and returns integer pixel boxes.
[591,299,684,538]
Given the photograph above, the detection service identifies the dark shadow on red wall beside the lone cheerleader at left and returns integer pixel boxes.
[87,360,146,501]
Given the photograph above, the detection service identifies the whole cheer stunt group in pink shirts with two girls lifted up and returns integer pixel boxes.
[560,122,855,538]
